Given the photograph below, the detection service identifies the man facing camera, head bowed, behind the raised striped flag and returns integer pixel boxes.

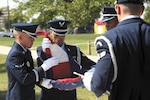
[37,20,95,100]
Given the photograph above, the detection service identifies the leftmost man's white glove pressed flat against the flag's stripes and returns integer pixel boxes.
[41,57,59,71]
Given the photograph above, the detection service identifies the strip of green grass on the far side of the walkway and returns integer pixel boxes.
[0,34,99,55]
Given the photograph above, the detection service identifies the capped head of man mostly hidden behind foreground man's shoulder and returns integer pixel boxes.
[102,6,118,30]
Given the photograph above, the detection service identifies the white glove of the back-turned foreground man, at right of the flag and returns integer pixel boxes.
[83,68,95,91]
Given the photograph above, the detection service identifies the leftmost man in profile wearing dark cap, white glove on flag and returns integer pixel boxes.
[6,23,58,100]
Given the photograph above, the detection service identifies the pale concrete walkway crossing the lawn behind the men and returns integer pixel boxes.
[0,46,97,62]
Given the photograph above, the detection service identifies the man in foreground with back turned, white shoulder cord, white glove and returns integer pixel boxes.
[83,0,150,100]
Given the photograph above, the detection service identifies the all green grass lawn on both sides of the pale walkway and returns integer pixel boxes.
[0,34,107,100]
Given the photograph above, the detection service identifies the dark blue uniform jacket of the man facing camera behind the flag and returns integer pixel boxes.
[37,44,95,100]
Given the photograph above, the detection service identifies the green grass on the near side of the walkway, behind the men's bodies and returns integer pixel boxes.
[0,54,107,100]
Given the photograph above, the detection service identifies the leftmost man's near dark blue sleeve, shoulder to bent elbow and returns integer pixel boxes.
[8,54,36,85]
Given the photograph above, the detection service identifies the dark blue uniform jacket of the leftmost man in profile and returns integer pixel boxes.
[6,42,44,100]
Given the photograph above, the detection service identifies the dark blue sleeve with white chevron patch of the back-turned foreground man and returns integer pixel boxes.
[91,36,113,97]
